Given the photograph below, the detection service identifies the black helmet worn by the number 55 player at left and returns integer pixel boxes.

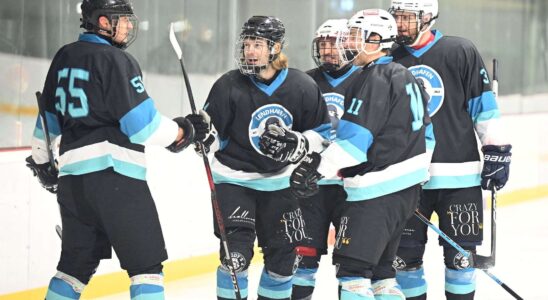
[80,0,138,48]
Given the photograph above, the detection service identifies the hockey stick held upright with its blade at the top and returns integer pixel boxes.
[169,23,242,300]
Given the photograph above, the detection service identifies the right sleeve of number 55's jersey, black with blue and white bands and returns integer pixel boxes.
[102,51,178,146]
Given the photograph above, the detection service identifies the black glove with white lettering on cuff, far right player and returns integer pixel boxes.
[481,145,512,190]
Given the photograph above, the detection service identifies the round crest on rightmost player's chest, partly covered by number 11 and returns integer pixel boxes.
[409,65,445,117]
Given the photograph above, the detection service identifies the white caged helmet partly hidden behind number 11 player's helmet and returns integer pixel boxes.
[312,19,348,72]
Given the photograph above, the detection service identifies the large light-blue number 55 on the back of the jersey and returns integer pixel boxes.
[55,68,89,118]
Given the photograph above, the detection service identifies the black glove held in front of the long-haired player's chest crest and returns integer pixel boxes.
[259,124,308,163]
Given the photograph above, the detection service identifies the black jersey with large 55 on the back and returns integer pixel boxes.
[32,33,178,180]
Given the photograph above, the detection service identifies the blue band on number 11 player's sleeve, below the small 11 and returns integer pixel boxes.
[335,120,373,163]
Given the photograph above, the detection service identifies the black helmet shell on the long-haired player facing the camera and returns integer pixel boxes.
[240,16,285,43]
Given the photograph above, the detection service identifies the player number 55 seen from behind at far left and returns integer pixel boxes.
[23,0,208,300]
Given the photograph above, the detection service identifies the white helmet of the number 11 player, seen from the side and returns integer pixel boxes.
[341,9,398,61]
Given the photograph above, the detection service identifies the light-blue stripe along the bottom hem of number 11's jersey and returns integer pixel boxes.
[344,169,428,201]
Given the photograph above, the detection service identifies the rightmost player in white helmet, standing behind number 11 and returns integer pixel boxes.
[390,0,511,299]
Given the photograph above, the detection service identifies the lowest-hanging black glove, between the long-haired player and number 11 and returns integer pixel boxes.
[289,152,323,198]
